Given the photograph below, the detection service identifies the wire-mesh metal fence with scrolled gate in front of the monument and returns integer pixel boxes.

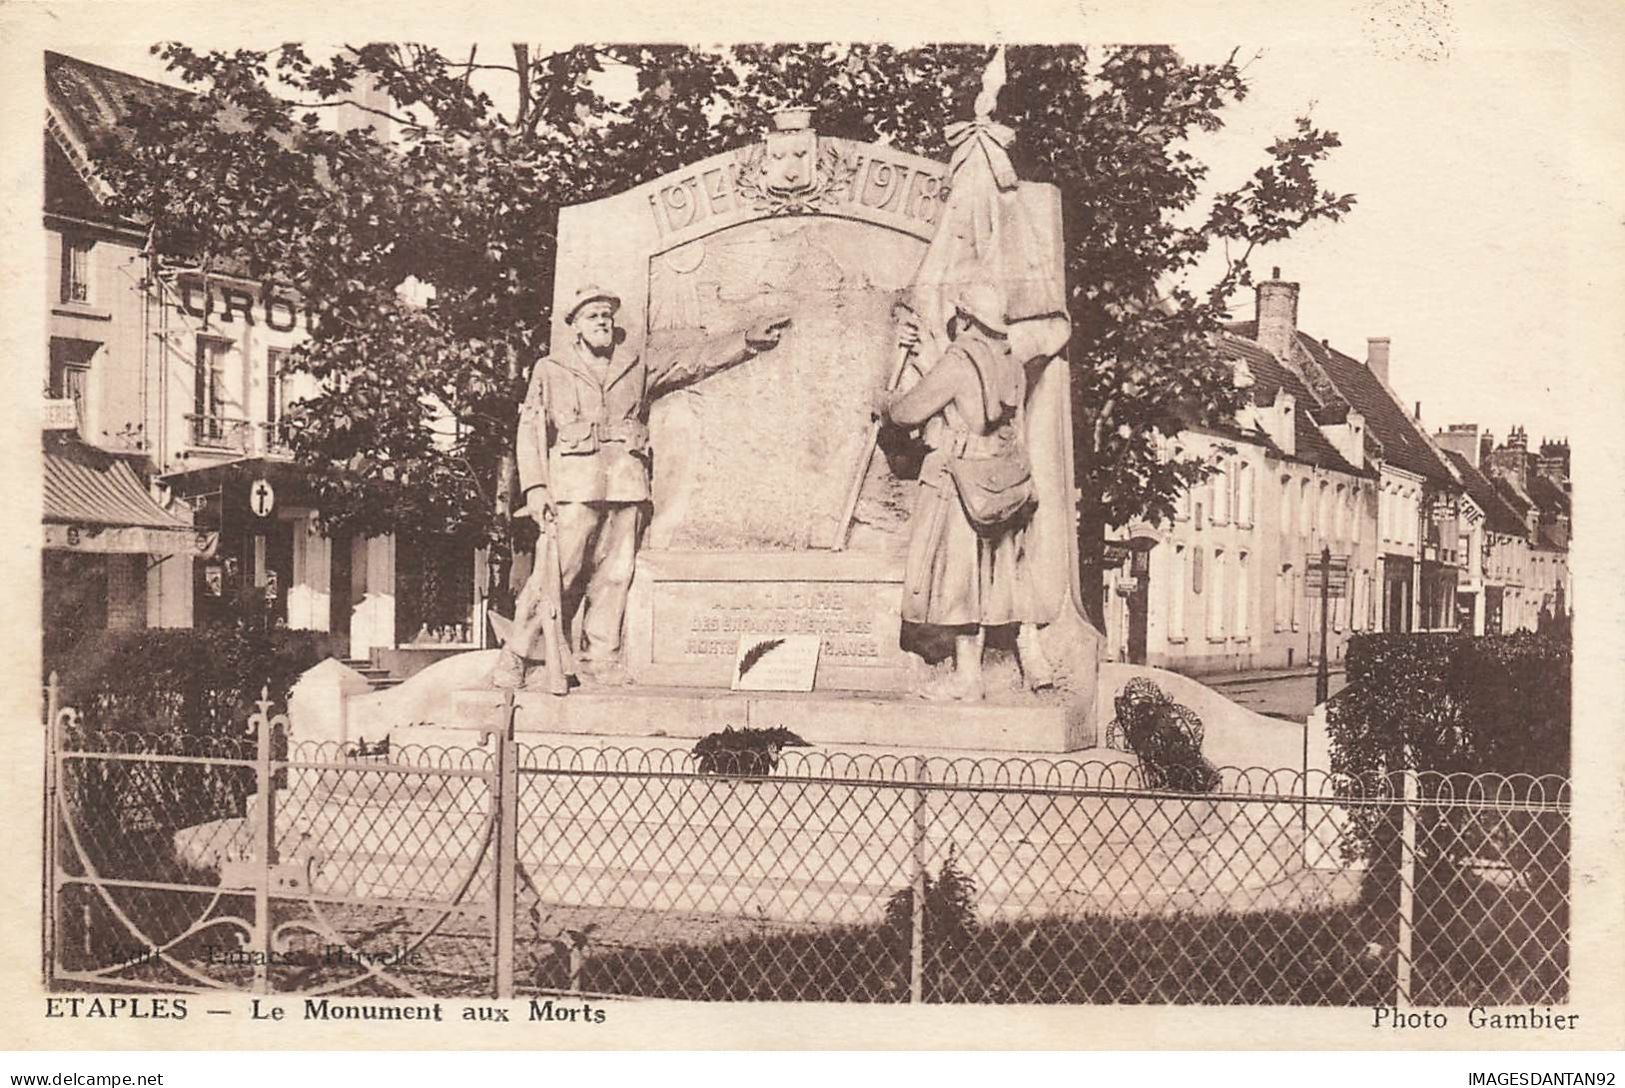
[46,691,1570,1005]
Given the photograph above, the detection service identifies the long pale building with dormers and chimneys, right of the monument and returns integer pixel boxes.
[1103,273,1484,676]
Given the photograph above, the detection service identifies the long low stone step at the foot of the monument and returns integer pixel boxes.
[457,687,1094,752]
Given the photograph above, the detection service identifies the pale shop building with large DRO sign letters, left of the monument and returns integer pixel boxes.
[44,54,481,659]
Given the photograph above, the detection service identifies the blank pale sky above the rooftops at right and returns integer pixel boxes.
[50,22,1597,442]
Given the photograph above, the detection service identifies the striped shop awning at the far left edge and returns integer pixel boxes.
[42,442,216,555]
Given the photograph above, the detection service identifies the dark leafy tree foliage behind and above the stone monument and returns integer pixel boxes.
[99,44,1354,622]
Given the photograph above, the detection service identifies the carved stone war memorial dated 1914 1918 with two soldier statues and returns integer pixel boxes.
[305,59,1295,763]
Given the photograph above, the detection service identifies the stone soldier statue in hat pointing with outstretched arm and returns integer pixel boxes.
[492,286,790,687]
